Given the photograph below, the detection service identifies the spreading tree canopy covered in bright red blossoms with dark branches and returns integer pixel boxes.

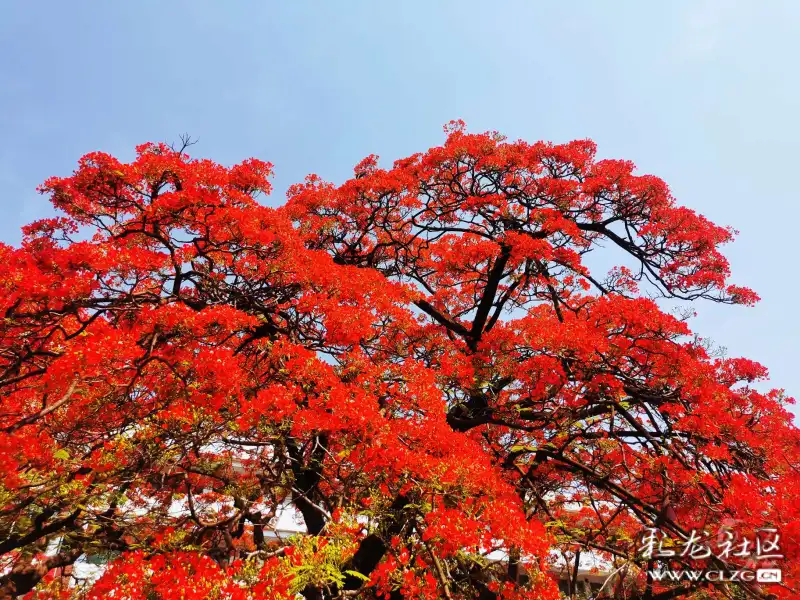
[0,122,800,600]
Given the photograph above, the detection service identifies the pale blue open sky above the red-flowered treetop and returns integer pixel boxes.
[0,0,800,412]
